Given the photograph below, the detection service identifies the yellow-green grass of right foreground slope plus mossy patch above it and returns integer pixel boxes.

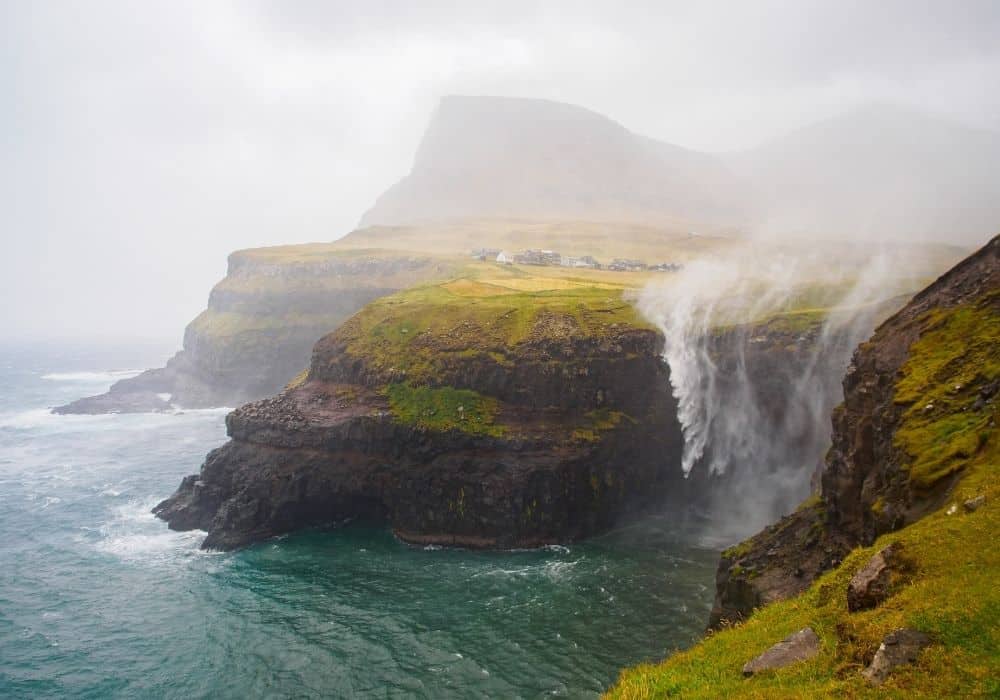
[609,293,1000,698]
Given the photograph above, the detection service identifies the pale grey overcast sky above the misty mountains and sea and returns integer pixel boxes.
[0,0,1000,345]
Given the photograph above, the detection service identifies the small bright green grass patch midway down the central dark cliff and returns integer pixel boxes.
[385,383,504,437]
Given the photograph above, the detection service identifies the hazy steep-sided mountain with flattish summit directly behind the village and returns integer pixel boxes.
[361,96,749,226]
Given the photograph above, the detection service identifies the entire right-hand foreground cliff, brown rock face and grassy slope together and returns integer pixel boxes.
[612,237,1000,697]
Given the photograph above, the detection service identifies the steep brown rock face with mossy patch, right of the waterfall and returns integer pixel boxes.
[711,237,1000,626]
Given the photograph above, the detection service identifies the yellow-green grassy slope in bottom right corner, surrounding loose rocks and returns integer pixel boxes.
[608,474,1000,698]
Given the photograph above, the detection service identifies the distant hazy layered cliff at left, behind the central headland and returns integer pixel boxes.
[55,244,450,413]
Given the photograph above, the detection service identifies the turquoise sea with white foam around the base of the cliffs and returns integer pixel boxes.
[0,348,717,698]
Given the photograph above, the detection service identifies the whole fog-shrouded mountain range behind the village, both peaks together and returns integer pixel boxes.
[361,96,1000,245]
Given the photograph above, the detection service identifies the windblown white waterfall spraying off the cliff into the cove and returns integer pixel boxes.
[639,249,912,539]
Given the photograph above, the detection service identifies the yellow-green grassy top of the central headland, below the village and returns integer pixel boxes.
[324,263,650,383]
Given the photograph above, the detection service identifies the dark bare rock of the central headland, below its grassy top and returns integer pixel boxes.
[154,327,689,549]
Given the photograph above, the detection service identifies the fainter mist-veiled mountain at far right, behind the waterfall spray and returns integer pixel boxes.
[725,105,1000,245]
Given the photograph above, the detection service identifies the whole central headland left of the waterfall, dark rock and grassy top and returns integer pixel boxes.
[155,266,683,549]
